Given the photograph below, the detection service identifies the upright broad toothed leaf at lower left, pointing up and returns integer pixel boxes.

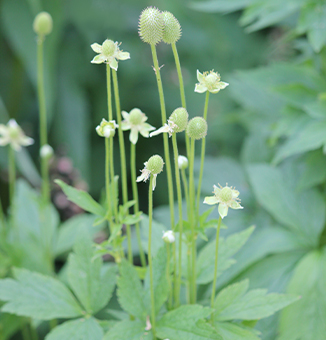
[68,230,116,314]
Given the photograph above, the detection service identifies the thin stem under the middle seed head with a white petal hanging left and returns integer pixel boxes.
[172,133,183,307]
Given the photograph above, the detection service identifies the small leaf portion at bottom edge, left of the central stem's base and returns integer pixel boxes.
[103,320,153,340]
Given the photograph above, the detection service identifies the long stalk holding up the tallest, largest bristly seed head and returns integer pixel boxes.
[151,44,174,228]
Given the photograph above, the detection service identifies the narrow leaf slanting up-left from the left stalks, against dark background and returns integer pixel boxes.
[55,179,105,217]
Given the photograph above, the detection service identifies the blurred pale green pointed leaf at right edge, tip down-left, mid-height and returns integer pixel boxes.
[273,120,326,164]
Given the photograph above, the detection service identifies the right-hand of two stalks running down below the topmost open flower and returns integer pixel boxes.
[112,70,132,263]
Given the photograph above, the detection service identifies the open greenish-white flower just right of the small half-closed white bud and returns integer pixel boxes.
[121,108,155,144]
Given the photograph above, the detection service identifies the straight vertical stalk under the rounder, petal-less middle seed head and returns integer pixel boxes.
[189,138,196,303]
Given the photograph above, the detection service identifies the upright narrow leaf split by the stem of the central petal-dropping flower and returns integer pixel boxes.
[144,247,169,315]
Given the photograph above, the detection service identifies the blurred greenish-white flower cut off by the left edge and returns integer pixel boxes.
[0,119,34,151]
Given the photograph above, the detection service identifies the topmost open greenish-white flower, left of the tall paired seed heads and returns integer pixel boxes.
[91,39,130,71]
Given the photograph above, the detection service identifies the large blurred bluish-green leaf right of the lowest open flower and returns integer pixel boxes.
[248,164,325,247]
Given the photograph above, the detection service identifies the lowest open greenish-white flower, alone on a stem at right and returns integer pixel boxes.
[204,185,243,218]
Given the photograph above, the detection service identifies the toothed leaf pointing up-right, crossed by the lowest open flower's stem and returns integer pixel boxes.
[197,227,255,284]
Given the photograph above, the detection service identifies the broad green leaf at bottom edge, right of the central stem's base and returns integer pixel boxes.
[156,305,222,340]
